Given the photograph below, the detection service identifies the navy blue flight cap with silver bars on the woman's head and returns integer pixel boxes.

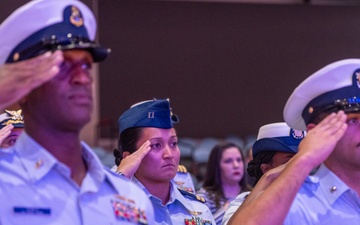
[118,99,179,134]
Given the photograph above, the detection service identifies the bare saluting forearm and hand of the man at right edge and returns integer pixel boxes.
[228,111,347,224]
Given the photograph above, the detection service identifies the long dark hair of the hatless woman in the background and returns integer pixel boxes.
[203,142,250,207]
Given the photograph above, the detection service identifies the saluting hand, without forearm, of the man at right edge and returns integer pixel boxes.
[298,111,347,167]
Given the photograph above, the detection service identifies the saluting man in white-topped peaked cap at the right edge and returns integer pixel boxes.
[229,59,360,225]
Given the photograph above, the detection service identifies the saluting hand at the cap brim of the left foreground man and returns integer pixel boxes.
[0,51,63,109]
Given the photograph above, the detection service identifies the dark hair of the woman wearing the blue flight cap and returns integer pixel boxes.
[113,127,143,166]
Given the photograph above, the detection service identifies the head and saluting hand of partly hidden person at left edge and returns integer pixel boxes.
[0,110,24,148]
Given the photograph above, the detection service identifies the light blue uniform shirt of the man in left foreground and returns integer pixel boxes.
[0,132,154,225]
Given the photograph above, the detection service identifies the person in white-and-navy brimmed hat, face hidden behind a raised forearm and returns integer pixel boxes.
[222,122,305,225]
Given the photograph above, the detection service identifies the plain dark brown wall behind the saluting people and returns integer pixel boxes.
[0,0,360,138]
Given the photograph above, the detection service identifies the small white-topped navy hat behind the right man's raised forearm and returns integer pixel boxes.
[252,122,306,158]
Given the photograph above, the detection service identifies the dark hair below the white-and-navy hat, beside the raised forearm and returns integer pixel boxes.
[247,151,276,185]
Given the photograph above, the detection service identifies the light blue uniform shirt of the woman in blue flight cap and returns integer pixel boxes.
[132,177,215,225]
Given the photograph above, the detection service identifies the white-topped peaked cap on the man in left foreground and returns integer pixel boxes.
[0,0,110,65]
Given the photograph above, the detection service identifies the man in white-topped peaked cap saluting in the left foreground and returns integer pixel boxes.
[0,0,154,225]
